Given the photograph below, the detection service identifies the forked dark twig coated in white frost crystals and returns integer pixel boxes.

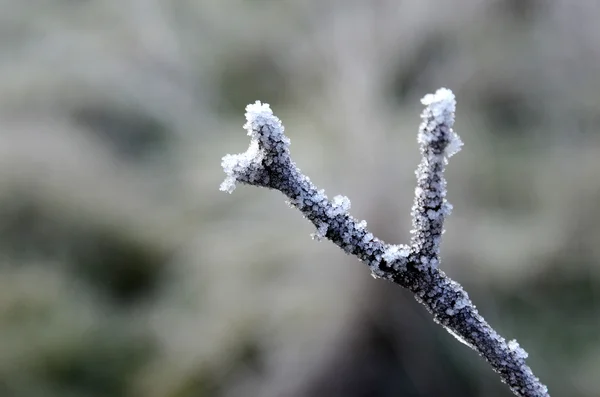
[221,88,549,397]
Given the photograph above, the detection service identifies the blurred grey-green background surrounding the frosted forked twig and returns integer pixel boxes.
[0,0,600,397]
